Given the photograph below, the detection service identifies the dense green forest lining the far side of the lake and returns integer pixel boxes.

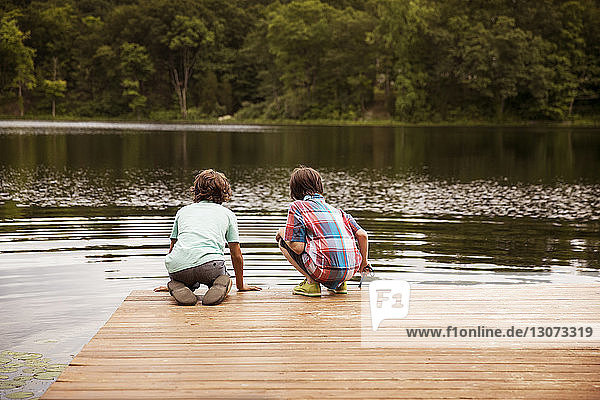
[0,0,600,122]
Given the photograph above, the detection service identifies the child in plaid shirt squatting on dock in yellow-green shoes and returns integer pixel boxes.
[276,167,369,296]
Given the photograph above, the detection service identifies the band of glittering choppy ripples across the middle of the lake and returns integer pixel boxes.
[0,167,600,220]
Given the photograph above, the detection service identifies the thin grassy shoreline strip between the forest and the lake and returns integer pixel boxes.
[0,115,600,128]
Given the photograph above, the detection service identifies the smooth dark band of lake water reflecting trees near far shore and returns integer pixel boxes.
[0,122,600,183]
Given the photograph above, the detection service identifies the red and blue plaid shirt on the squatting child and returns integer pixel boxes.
[284,193,362,289]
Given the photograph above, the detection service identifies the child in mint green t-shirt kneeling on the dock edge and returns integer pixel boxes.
[165,169,260,305]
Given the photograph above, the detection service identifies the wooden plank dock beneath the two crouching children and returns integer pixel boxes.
[43,285,600,399]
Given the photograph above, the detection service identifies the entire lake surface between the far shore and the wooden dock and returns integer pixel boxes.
[0,121,600,372]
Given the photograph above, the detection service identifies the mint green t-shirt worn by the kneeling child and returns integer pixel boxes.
[165,201,240,273]
